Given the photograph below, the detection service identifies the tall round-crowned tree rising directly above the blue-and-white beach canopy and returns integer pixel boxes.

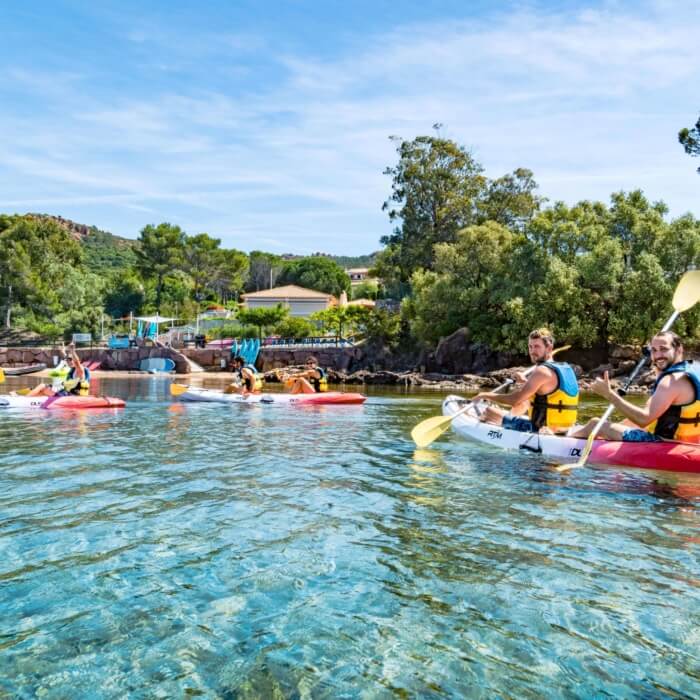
[136,223,185,311]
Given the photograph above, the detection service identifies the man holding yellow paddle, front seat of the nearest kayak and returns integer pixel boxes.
[472,328,579,433]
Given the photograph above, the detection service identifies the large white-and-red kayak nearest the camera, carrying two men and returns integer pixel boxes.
[442,396,700,473]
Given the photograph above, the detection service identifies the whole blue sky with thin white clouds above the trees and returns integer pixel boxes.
[0,0,700,254]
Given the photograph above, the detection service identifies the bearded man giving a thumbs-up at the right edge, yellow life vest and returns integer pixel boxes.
[571,331,700,444]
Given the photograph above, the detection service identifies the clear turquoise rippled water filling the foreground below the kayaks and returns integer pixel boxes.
[0,378,700,698]
